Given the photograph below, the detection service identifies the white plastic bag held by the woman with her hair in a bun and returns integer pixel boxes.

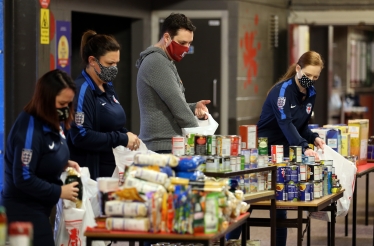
[112,140,157,185]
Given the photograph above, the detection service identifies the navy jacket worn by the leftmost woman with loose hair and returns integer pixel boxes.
[1,112,65,212]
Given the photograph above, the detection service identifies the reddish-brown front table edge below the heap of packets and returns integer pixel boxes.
[84,213,249,241]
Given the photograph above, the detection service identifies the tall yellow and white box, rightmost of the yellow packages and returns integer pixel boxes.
[348,119,369,165]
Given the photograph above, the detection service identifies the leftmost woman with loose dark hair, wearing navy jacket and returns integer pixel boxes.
[1,69,79,246]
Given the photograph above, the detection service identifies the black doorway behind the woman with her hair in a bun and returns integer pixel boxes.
[71,11,134,129]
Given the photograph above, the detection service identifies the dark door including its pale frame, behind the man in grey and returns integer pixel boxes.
[151,10,228,135]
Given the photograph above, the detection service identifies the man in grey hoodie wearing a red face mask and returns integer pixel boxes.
[136,13,210,153]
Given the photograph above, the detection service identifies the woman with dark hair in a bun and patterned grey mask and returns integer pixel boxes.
[68,30,140,180]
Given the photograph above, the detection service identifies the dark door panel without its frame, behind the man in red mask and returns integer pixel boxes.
[160,19,221,134]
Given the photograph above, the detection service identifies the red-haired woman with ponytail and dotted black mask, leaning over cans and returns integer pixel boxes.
[257,51,325,246]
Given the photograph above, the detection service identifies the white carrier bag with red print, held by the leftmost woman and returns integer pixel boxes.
[54,167,107,246]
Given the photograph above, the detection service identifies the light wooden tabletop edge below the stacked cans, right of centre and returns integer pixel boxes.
[251,189,344,210]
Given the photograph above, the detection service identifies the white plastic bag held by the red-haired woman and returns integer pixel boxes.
[317,145,357,216]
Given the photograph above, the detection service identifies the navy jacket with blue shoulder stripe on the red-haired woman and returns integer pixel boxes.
[257,78,318,156]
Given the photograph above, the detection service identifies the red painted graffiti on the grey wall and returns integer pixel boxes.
[240,15,261,94]
